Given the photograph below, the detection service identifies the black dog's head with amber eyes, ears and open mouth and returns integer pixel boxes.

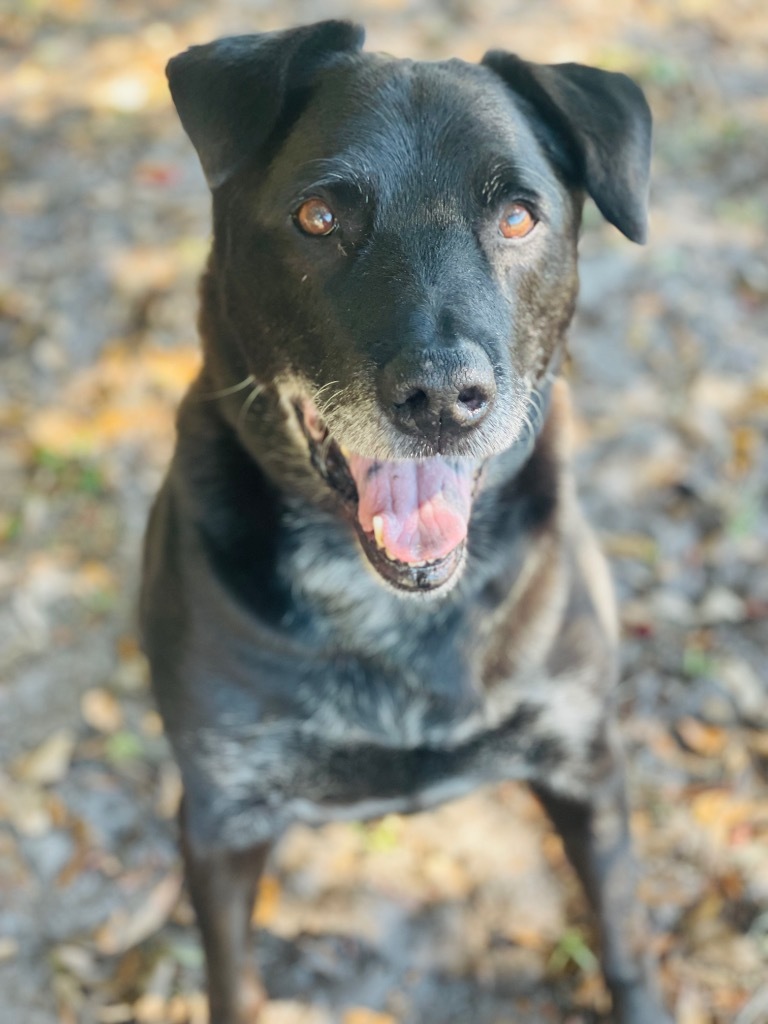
[168,22,650,590]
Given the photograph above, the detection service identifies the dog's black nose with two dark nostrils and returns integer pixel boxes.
[382,348,496,440]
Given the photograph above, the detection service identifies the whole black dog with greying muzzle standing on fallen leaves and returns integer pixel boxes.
[142,22,670,1024]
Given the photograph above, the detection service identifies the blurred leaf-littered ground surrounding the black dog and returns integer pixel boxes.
[0,0,768,1024]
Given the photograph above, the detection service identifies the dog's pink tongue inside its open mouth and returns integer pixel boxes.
[348,454,475,563]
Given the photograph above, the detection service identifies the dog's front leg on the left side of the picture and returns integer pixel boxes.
[179,807,270,1024]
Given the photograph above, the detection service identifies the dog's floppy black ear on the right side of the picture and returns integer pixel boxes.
[482,50,651,244]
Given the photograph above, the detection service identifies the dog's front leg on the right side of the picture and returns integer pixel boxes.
[534,758,672,1024]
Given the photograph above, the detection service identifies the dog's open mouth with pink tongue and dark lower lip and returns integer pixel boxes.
[295,400,479,592]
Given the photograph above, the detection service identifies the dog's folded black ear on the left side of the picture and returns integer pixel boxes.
[166,22,364,189]
